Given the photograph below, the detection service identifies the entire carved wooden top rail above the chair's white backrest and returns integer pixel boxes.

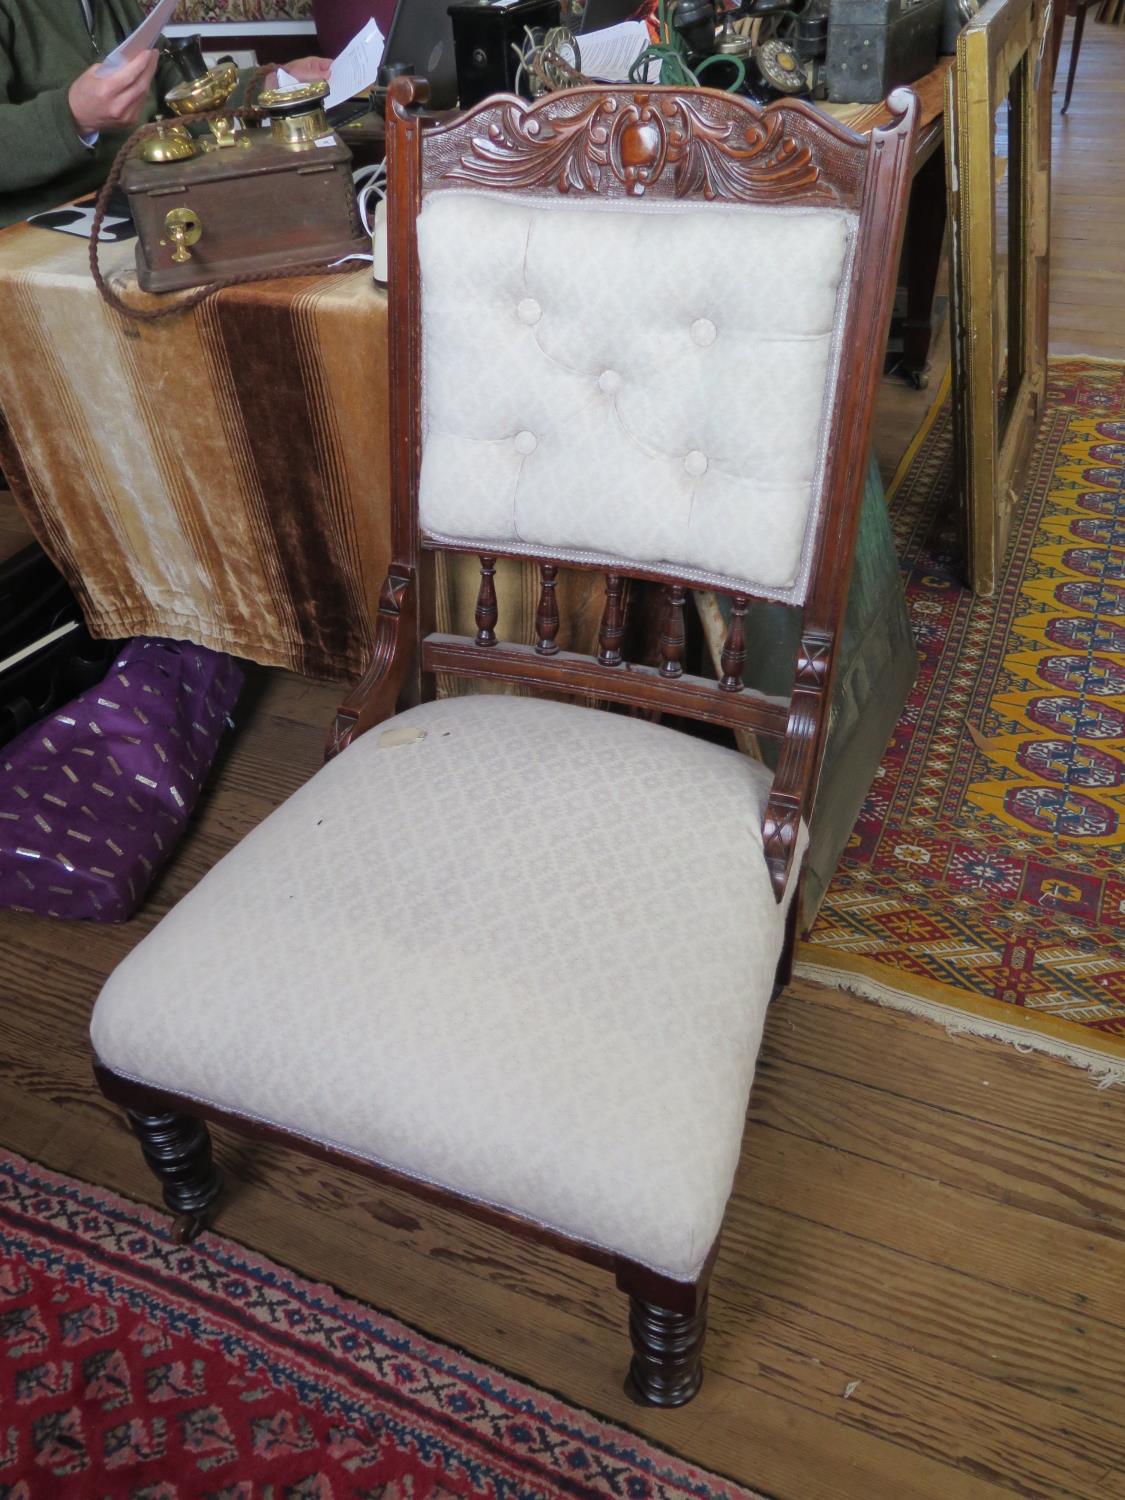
[411,84,867,209]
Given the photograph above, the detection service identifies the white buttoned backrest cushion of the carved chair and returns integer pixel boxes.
[419,191,855,597]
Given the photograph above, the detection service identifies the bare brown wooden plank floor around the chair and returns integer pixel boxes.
[0,24,1125,1500]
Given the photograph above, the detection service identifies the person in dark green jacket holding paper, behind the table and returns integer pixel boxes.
[0,0,332,225]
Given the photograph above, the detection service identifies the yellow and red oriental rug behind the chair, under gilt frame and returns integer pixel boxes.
[797,359,1125,1080]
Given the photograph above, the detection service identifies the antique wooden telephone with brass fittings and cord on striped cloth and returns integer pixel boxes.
[90,41,369,320]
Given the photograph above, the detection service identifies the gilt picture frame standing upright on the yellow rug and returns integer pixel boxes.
[945,0,1059,596]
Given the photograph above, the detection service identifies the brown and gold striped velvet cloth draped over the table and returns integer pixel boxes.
[0,225,390,678]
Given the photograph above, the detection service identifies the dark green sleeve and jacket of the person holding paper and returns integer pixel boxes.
[0,0,180,225]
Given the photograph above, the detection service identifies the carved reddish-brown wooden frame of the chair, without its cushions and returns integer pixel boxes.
[95,78,918,1406]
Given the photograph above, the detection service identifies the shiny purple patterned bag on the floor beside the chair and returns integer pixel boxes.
[0,638,242,923]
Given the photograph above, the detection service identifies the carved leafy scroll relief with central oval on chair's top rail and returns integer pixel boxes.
[444,93,837,203]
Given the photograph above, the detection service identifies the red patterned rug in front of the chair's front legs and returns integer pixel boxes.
[0,1152,761,1500]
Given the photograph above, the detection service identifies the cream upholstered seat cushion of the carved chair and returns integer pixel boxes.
[93,696,804,1280]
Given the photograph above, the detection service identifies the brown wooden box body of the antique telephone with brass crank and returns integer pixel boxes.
[122,131,371,291]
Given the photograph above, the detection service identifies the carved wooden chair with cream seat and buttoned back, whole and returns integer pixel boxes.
[85,80,917,1406]
